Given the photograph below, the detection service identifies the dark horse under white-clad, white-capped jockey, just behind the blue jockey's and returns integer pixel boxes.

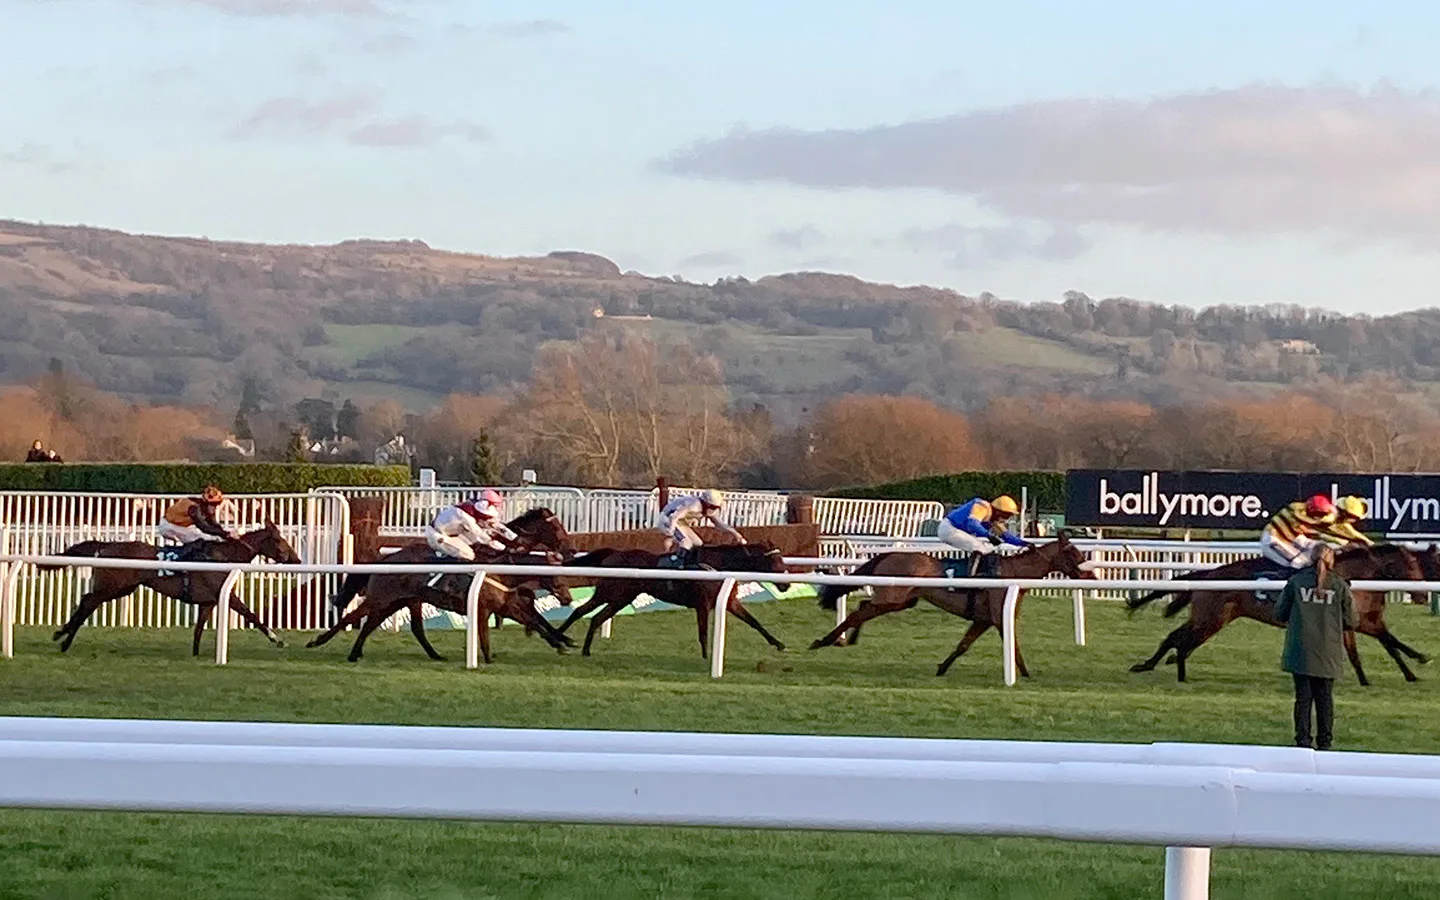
[559,541,789,660]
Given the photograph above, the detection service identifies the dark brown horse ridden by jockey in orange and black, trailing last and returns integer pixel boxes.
[37,523,301,657]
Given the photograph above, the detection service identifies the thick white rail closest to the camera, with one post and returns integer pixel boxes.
[0,719,1440,900]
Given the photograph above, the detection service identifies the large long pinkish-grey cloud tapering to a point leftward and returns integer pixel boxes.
[654,85,1440,241]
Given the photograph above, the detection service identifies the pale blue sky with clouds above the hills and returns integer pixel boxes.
[0,0,1440,314]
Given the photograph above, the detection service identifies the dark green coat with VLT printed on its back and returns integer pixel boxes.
[1274,569,1355,678]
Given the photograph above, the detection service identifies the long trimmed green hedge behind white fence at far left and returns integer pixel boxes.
[0,462,410,494]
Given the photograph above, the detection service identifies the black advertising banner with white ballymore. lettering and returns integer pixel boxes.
[1066,469,1440,534]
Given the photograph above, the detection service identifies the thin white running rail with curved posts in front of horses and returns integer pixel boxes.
[0,554,1440,685]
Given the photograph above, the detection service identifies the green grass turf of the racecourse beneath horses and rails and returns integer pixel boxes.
[0,599,1440,900]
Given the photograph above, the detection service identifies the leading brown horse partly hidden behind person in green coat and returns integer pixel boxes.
[1126,544,1440,685]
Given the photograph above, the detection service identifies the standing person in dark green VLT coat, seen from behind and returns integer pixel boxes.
[1274,547,1355,750]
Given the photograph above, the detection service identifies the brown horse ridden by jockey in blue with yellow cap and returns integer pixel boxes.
[811,533,1094,678]
